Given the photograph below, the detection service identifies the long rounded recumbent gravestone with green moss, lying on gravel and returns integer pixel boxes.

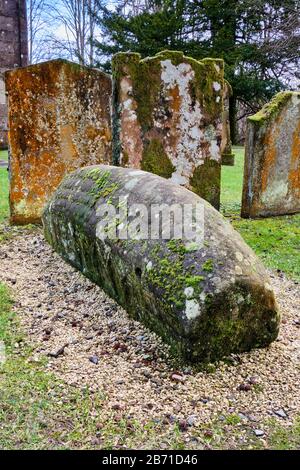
[43,165,279,361]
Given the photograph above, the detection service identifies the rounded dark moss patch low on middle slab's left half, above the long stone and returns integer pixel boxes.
[141,139,175,178]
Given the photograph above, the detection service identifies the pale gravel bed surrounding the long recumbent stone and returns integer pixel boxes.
[0,233,300,448]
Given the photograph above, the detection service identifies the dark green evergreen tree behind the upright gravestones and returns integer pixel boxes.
[96,0,300,142]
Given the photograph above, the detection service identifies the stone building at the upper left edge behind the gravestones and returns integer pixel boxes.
[0,0,28,148]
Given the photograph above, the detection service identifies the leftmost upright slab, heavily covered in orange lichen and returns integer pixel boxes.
[6,60,111,224]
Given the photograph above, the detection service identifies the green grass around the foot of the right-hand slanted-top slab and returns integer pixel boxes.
[221,147,300,280]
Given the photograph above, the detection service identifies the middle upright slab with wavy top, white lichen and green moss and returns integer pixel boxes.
[112,51,224,208]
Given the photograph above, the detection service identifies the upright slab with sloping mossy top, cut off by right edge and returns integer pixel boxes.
[242,91,300,218]
